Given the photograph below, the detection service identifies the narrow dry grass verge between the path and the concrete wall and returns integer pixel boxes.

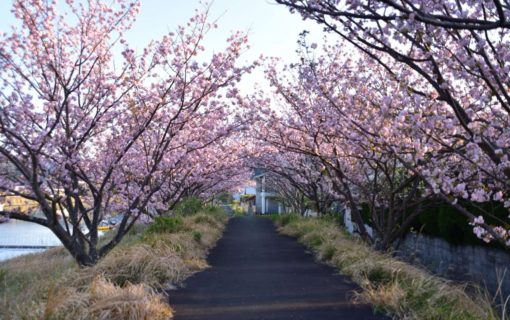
[272,215,501,320]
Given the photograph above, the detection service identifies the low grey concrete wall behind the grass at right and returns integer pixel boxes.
[397,233,510,297]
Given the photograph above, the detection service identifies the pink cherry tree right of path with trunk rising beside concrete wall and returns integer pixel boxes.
[253,35,508,249]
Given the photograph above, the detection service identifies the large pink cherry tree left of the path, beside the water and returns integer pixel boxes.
[0,0,252,266]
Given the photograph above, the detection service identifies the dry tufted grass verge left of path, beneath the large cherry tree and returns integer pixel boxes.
[0,209,227,320]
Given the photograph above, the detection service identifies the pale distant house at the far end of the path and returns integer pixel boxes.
[252,169,284,214]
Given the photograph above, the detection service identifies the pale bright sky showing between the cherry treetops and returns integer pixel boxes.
[0,0,324,91]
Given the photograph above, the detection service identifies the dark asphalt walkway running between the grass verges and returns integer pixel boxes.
[169,217,387,320]
